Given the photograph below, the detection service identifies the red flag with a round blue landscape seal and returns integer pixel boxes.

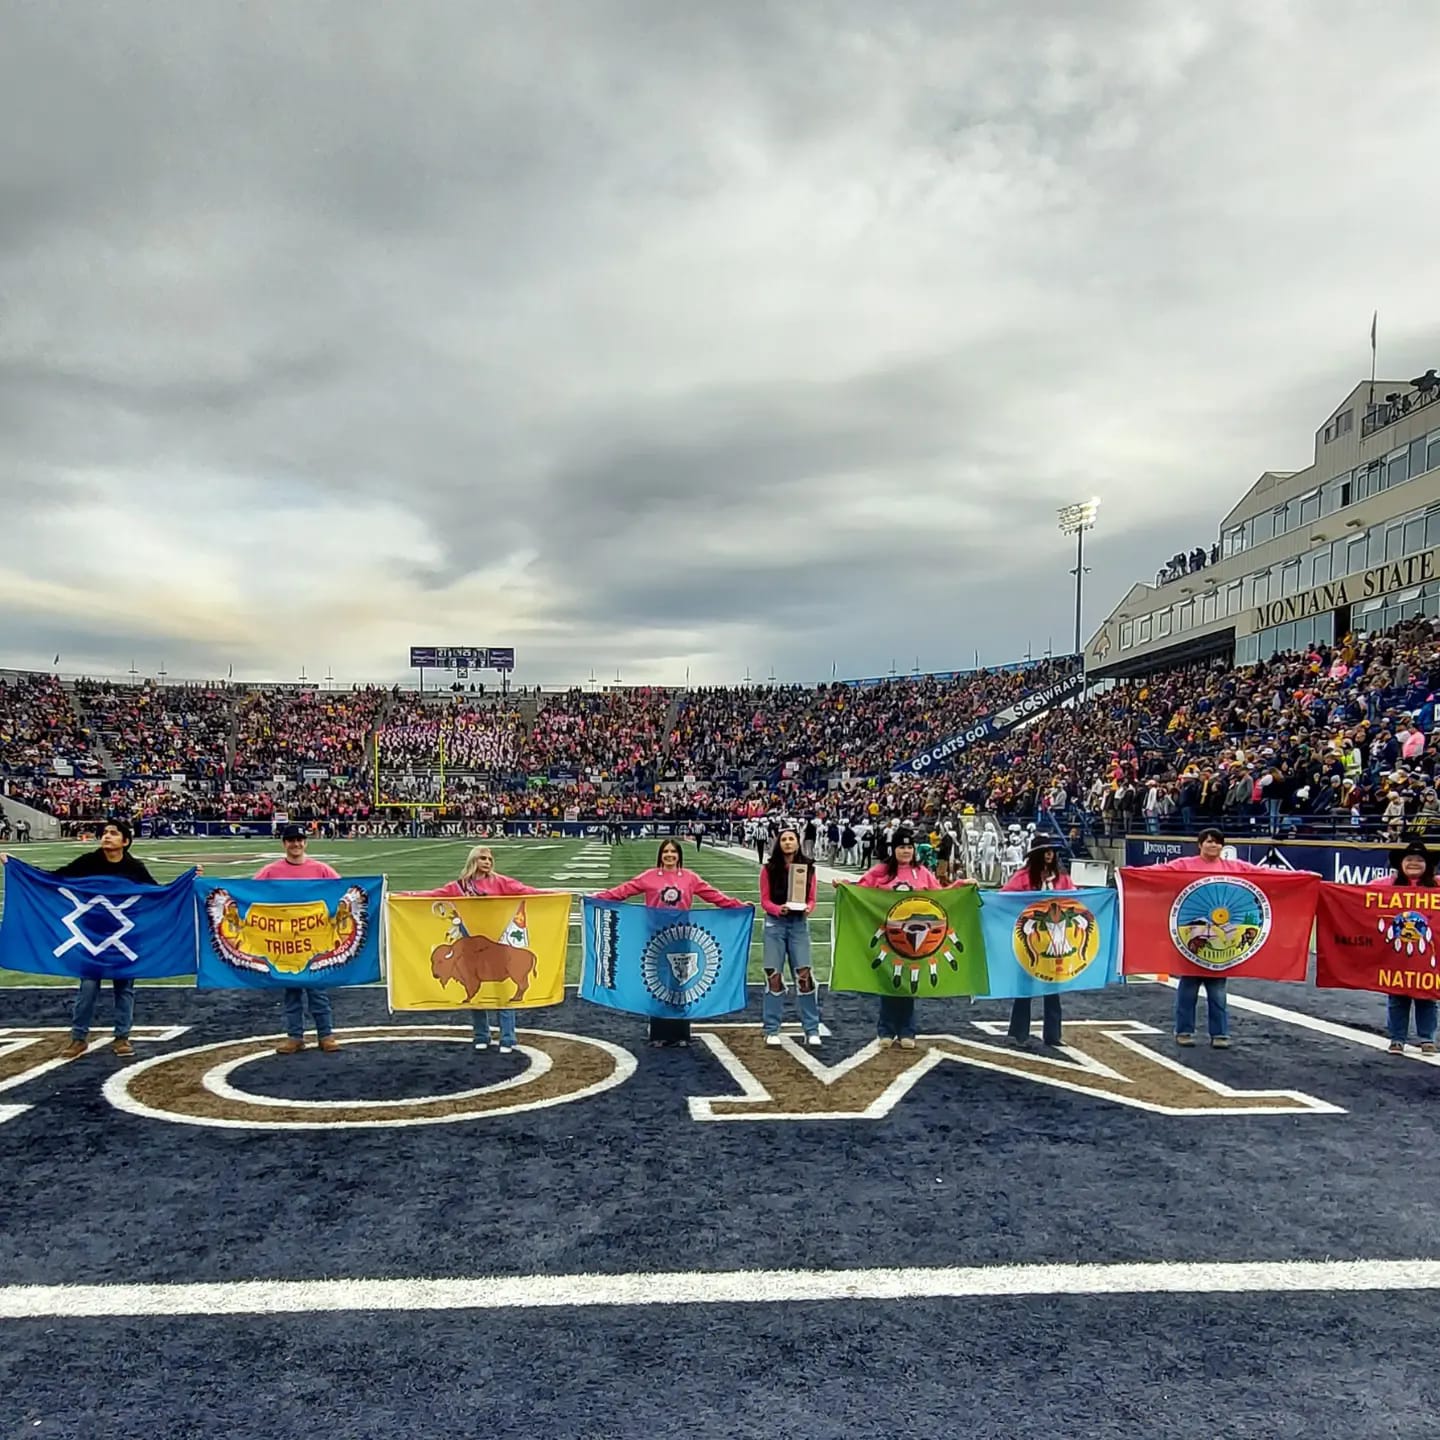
[1120,865,1320,981]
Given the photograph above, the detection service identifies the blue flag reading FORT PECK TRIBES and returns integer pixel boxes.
[194,876,384,989]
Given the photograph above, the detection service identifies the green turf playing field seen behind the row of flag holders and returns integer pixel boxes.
[0,838,834,985]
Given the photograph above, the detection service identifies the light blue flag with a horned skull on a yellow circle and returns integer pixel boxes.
[976,888,1120,999]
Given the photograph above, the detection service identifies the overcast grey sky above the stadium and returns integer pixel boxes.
[0,0,1440,684]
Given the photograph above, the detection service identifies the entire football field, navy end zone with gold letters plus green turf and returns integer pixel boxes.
[0,840,1440,1440]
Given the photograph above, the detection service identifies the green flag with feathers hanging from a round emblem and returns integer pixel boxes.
[829,886,989,995]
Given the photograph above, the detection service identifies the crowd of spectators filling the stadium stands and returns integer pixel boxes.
[8,621,1440,835]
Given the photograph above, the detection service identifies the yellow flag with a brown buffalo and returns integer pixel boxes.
[386,894,570,1009]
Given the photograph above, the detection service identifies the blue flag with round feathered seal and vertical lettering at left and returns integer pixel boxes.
[580,896,755,1020]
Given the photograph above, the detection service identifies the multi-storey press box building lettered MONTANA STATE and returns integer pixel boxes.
[1084,370,1440,680]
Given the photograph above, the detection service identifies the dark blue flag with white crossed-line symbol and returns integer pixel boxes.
[0,857,194,981]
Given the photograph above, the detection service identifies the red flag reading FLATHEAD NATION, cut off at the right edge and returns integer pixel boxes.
[1315,886,1440,999]
